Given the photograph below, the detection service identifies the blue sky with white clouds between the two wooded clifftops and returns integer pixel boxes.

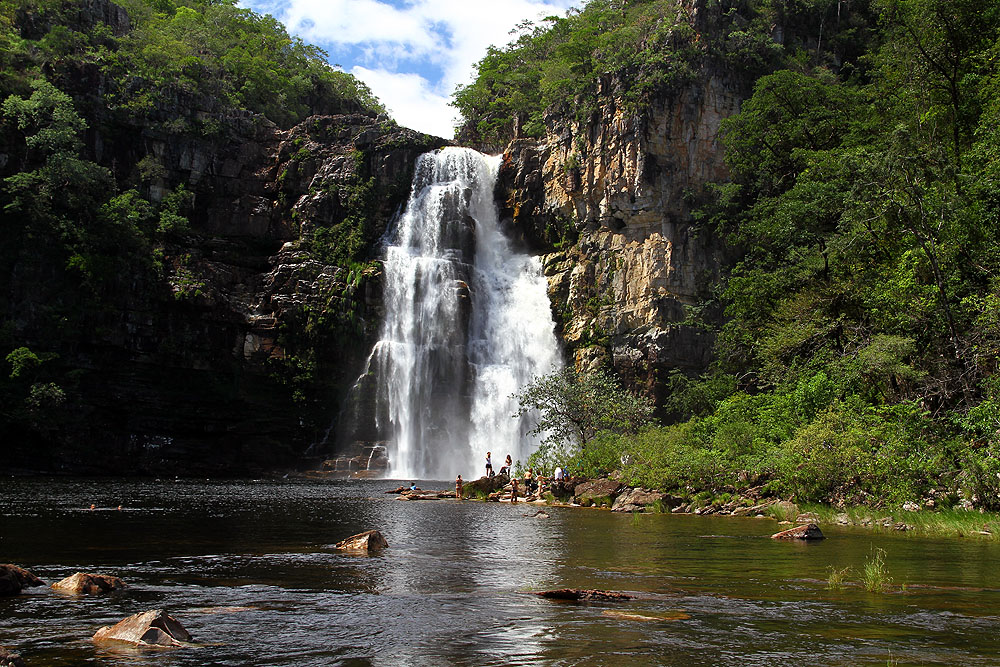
[240,0,581,138]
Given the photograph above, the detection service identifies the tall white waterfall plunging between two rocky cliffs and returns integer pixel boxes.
[366,148,559,479]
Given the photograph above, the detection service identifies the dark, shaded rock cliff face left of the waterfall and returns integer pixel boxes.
[0,78,443,474]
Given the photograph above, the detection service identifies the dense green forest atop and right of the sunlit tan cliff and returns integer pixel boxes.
[455,0,1000,509]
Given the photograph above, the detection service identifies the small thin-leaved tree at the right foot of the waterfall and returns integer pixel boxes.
[514,368,653,448]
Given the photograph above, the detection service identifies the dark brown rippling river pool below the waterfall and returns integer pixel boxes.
[0,480,1000,667]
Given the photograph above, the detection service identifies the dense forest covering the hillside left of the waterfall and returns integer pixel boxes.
[0,0,398,470]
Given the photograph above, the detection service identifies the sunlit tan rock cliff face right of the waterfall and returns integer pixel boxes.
[498,73,745,398]
